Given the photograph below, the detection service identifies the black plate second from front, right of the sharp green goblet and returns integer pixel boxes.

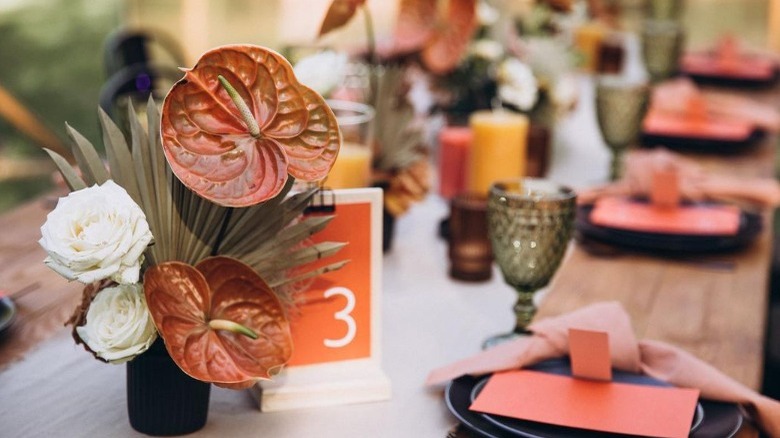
[575,204,762,253]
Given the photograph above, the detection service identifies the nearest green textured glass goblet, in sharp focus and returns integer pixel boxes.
[483,178,576,348]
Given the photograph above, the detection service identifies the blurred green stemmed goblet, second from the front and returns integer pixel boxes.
[596,75,650,181]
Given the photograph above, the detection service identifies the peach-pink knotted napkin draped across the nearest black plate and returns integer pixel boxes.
[426,302,780,438]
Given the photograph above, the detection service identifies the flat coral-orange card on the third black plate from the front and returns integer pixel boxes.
[642,110,755,141]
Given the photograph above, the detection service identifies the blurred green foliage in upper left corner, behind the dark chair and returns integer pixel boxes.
[0,0,122,211]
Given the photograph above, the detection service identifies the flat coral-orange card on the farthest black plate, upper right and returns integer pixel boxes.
[680,53,775,80]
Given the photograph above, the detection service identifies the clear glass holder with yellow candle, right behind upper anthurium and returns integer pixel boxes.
[325,100,374,189]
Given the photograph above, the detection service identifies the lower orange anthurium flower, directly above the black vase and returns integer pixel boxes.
[144,256,292,389]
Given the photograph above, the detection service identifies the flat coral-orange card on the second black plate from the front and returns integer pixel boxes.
[590,197,740,236]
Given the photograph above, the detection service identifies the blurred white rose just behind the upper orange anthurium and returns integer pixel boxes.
[294,50,347,96]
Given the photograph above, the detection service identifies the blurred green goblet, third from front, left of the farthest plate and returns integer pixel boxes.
[642,20,684,82]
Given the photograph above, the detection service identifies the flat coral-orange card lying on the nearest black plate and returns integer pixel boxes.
[470,370,699,437]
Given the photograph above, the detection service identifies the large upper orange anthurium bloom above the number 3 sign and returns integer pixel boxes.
[161,45,341,207]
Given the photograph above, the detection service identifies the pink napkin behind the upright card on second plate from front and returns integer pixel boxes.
[577,148,780,208]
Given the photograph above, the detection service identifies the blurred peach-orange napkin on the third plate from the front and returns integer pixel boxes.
[645,78,780,133]
